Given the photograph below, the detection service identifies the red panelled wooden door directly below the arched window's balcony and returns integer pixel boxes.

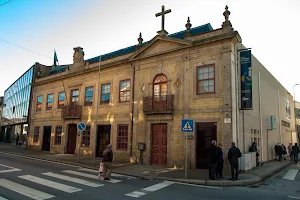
[152,124,168,165]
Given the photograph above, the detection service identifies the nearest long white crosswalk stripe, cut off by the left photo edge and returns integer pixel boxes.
[0,179,55,200]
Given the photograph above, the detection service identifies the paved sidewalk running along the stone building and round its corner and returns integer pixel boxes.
[0,143,292,186]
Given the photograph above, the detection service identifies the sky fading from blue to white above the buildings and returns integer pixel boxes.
[0,0,300,101]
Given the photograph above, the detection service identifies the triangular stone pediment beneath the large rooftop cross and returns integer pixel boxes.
[129,35,192,61]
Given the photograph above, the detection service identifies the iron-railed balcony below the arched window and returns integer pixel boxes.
[143,95,174,115]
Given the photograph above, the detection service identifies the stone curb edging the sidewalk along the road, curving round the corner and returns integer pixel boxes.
[0,151,292,186]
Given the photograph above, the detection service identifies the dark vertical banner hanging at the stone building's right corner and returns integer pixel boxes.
[240,50,253,110]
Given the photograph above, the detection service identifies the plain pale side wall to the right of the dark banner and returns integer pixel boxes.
[238,45,297,161]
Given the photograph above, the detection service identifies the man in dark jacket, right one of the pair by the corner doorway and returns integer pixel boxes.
[228,142,242,180]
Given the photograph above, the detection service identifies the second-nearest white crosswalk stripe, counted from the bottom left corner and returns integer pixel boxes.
[18,175,82,193]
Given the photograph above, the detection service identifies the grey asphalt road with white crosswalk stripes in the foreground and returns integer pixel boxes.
[0,154,300,200]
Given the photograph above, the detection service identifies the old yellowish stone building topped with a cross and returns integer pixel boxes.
[29,6,293,168]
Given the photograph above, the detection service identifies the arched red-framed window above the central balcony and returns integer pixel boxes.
[153,74,168,101]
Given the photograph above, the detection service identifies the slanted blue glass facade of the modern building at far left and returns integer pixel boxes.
[2,67,33,124]
